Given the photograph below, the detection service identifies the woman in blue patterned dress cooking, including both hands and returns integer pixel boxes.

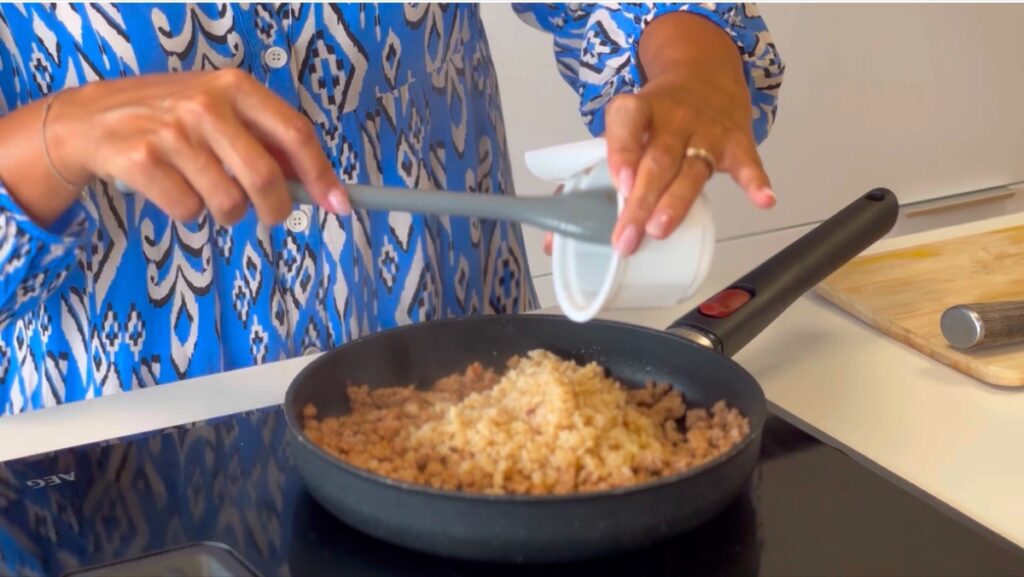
[0,4,782,414]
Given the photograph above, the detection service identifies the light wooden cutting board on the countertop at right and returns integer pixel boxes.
[817,225,1024,386]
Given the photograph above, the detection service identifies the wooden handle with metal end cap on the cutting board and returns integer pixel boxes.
[939,300,1024,349]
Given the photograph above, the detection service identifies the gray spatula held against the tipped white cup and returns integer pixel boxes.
[118,180,618,244]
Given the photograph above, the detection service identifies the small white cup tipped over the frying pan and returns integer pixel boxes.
[526,138,715,322]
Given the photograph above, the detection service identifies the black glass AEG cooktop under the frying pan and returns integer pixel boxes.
[0,408,1024,577]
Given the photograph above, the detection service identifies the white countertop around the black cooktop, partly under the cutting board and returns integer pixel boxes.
[0,214,1024,546]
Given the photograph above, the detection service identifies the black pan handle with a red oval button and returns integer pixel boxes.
[668,189,899,357]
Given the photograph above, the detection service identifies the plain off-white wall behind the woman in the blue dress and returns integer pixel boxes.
[482,4,1024,303]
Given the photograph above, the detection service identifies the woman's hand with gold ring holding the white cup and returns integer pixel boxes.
[605,12,775,254]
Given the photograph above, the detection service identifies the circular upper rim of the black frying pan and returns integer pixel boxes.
[283,314,767,504]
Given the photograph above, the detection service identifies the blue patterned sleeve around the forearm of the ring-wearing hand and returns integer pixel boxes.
[513,3,785,143]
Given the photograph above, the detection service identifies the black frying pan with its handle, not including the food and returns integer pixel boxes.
[285,189,898,562]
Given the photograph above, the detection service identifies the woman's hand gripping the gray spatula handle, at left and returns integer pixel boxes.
[38,69,349,224]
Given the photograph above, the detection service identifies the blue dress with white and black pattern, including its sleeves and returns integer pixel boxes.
[0,3,783,414]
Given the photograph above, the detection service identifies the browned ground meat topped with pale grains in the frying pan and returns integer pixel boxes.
[303,351,750,495]
